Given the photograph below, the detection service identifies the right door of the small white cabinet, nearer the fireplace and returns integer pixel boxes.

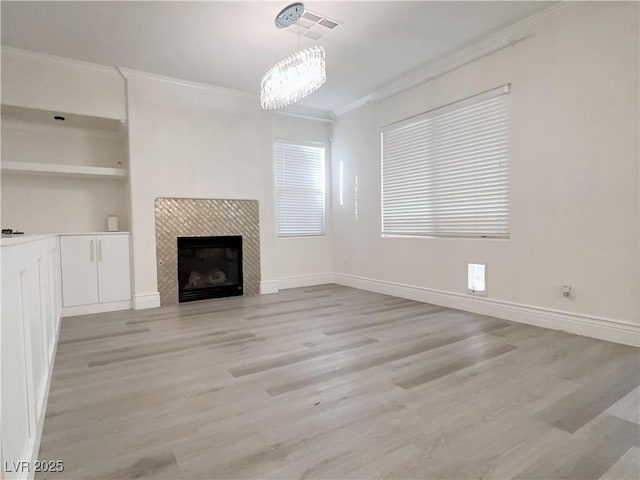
[97,235,131,302]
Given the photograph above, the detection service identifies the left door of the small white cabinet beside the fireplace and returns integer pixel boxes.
[60,235,98,307]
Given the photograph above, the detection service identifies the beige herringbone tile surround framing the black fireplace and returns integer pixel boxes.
[155,198,260,305]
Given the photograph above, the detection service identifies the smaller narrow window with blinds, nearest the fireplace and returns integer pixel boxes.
[274,142,325,237]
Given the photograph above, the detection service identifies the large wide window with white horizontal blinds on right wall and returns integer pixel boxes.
[381,85,509,238]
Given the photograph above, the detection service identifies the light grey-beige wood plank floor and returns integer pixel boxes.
[38,285,640,479]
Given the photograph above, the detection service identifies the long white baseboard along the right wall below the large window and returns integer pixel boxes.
[334,273,640,347]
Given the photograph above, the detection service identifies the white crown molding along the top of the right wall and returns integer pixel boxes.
[334,2,580,117]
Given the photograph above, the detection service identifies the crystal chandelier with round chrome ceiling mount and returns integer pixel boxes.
[260,3,327,110]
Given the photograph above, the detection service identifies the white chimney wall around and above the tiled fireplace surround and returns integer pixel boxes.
[127,73,278,308]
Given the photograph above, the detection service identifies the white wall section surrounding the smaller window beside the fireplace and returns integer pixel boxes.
[272,114,333,288]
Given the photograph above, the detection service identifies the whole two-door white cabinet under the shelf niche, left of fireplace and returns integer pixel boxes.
[60,233,131,316]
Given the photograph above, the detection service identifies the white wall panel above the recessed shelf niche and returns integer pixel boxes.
[1,46,126,120]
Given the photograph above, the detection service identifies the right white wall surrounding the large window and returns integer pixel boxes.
[333,3,640,328]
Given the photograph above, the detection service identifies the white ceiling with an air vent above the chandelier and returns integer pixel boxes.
[1,0,553,111]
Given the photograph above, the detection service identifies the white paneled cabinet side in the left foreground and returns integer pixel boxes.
[0,235,60,479]
